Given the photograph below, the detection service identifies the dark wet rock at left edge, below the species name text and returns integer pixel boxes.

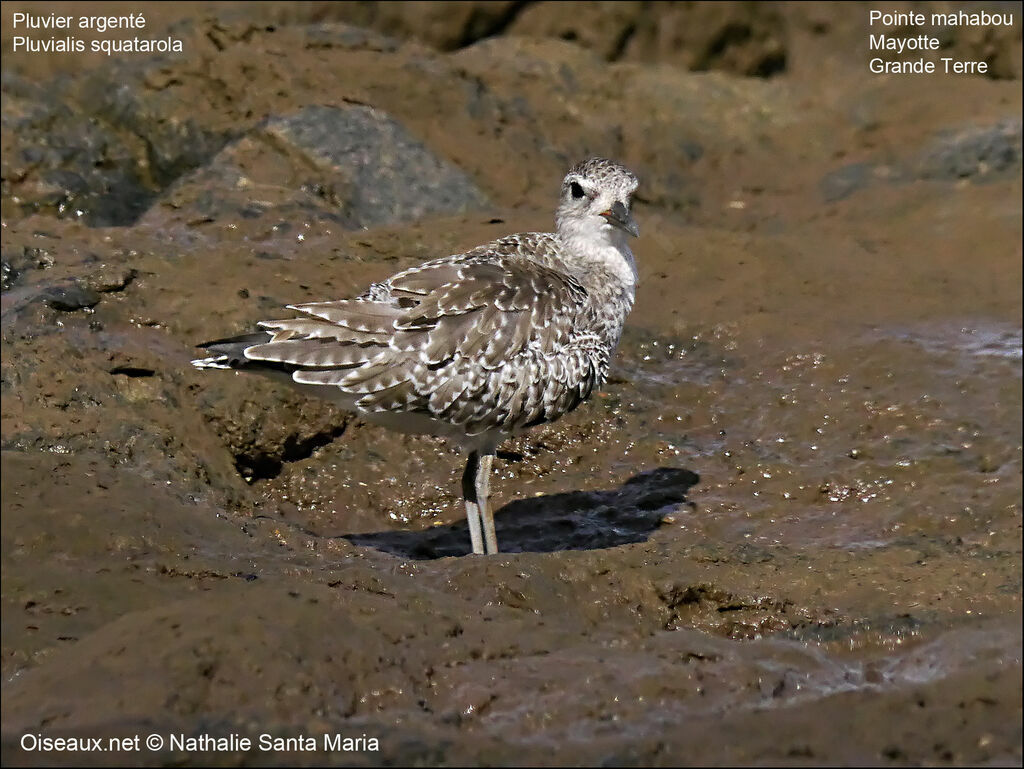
[2,47,229,226]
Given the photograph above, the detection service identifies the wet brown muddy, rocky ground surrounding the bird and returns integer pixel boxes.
[2,3,1022,765]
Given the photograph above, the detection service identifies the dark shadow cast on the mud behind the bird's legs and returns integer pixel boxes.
[344,467,700,560]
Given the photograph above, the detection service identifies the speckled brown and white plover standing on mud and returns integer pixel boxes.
[191,158,640,555]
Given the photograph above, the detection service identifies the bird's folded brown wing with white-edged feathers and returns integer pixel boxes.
[245,241,587,416]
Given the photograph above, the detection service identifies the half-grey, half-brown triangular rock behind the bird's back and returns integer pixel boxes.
[153,104,487,229]
